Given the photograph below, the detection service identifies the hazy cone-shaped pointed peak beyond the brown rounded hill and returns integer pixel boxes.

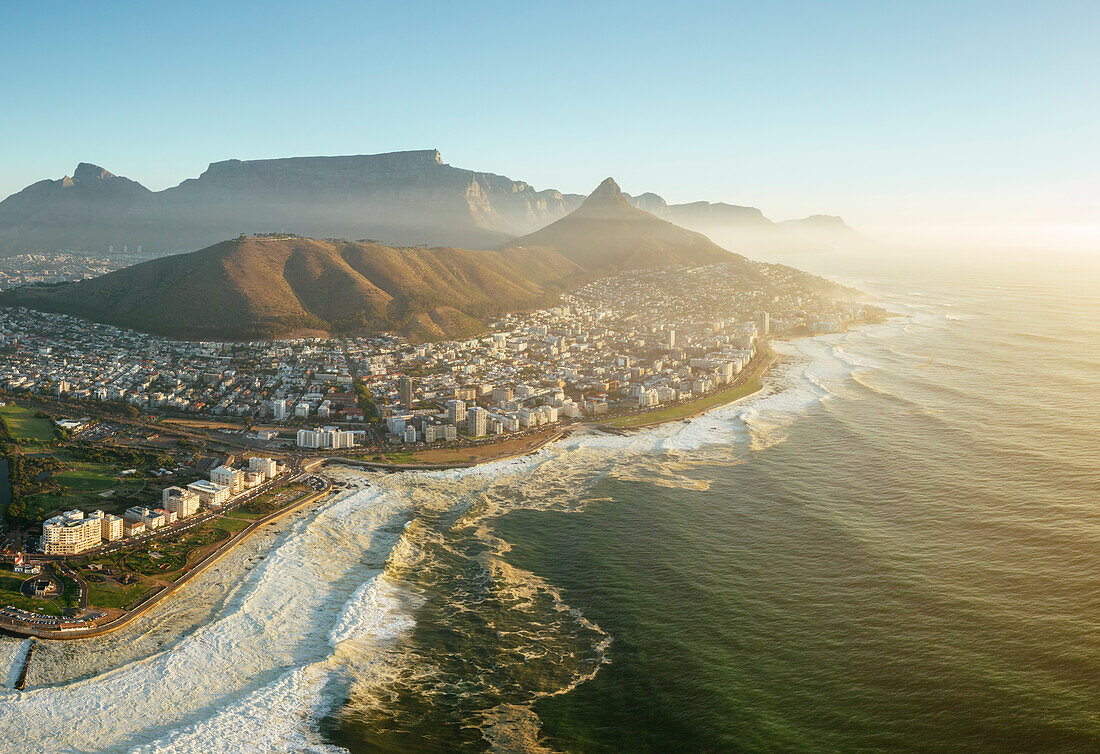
[505,178,747,272]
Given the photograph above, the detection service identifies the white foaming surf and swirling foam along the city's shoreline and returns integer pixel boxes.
[0,310,919,752]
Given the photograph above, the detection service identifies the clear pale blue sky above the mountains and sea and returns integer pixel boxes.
[0,0,1100,246]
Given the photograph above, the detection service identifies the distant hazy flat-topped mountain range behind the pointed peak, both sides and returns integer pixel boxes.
[0,150,858,255]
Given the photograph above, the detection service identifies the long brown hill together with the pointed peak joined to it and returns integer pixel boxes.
[0,178,774,340]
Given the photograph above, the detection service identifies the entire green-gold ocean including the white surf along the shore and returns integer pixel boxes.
[0,245,1100,752]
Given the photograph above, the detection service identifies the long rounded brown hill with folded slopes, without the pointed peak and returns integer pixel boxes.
[0,238,581,340]
